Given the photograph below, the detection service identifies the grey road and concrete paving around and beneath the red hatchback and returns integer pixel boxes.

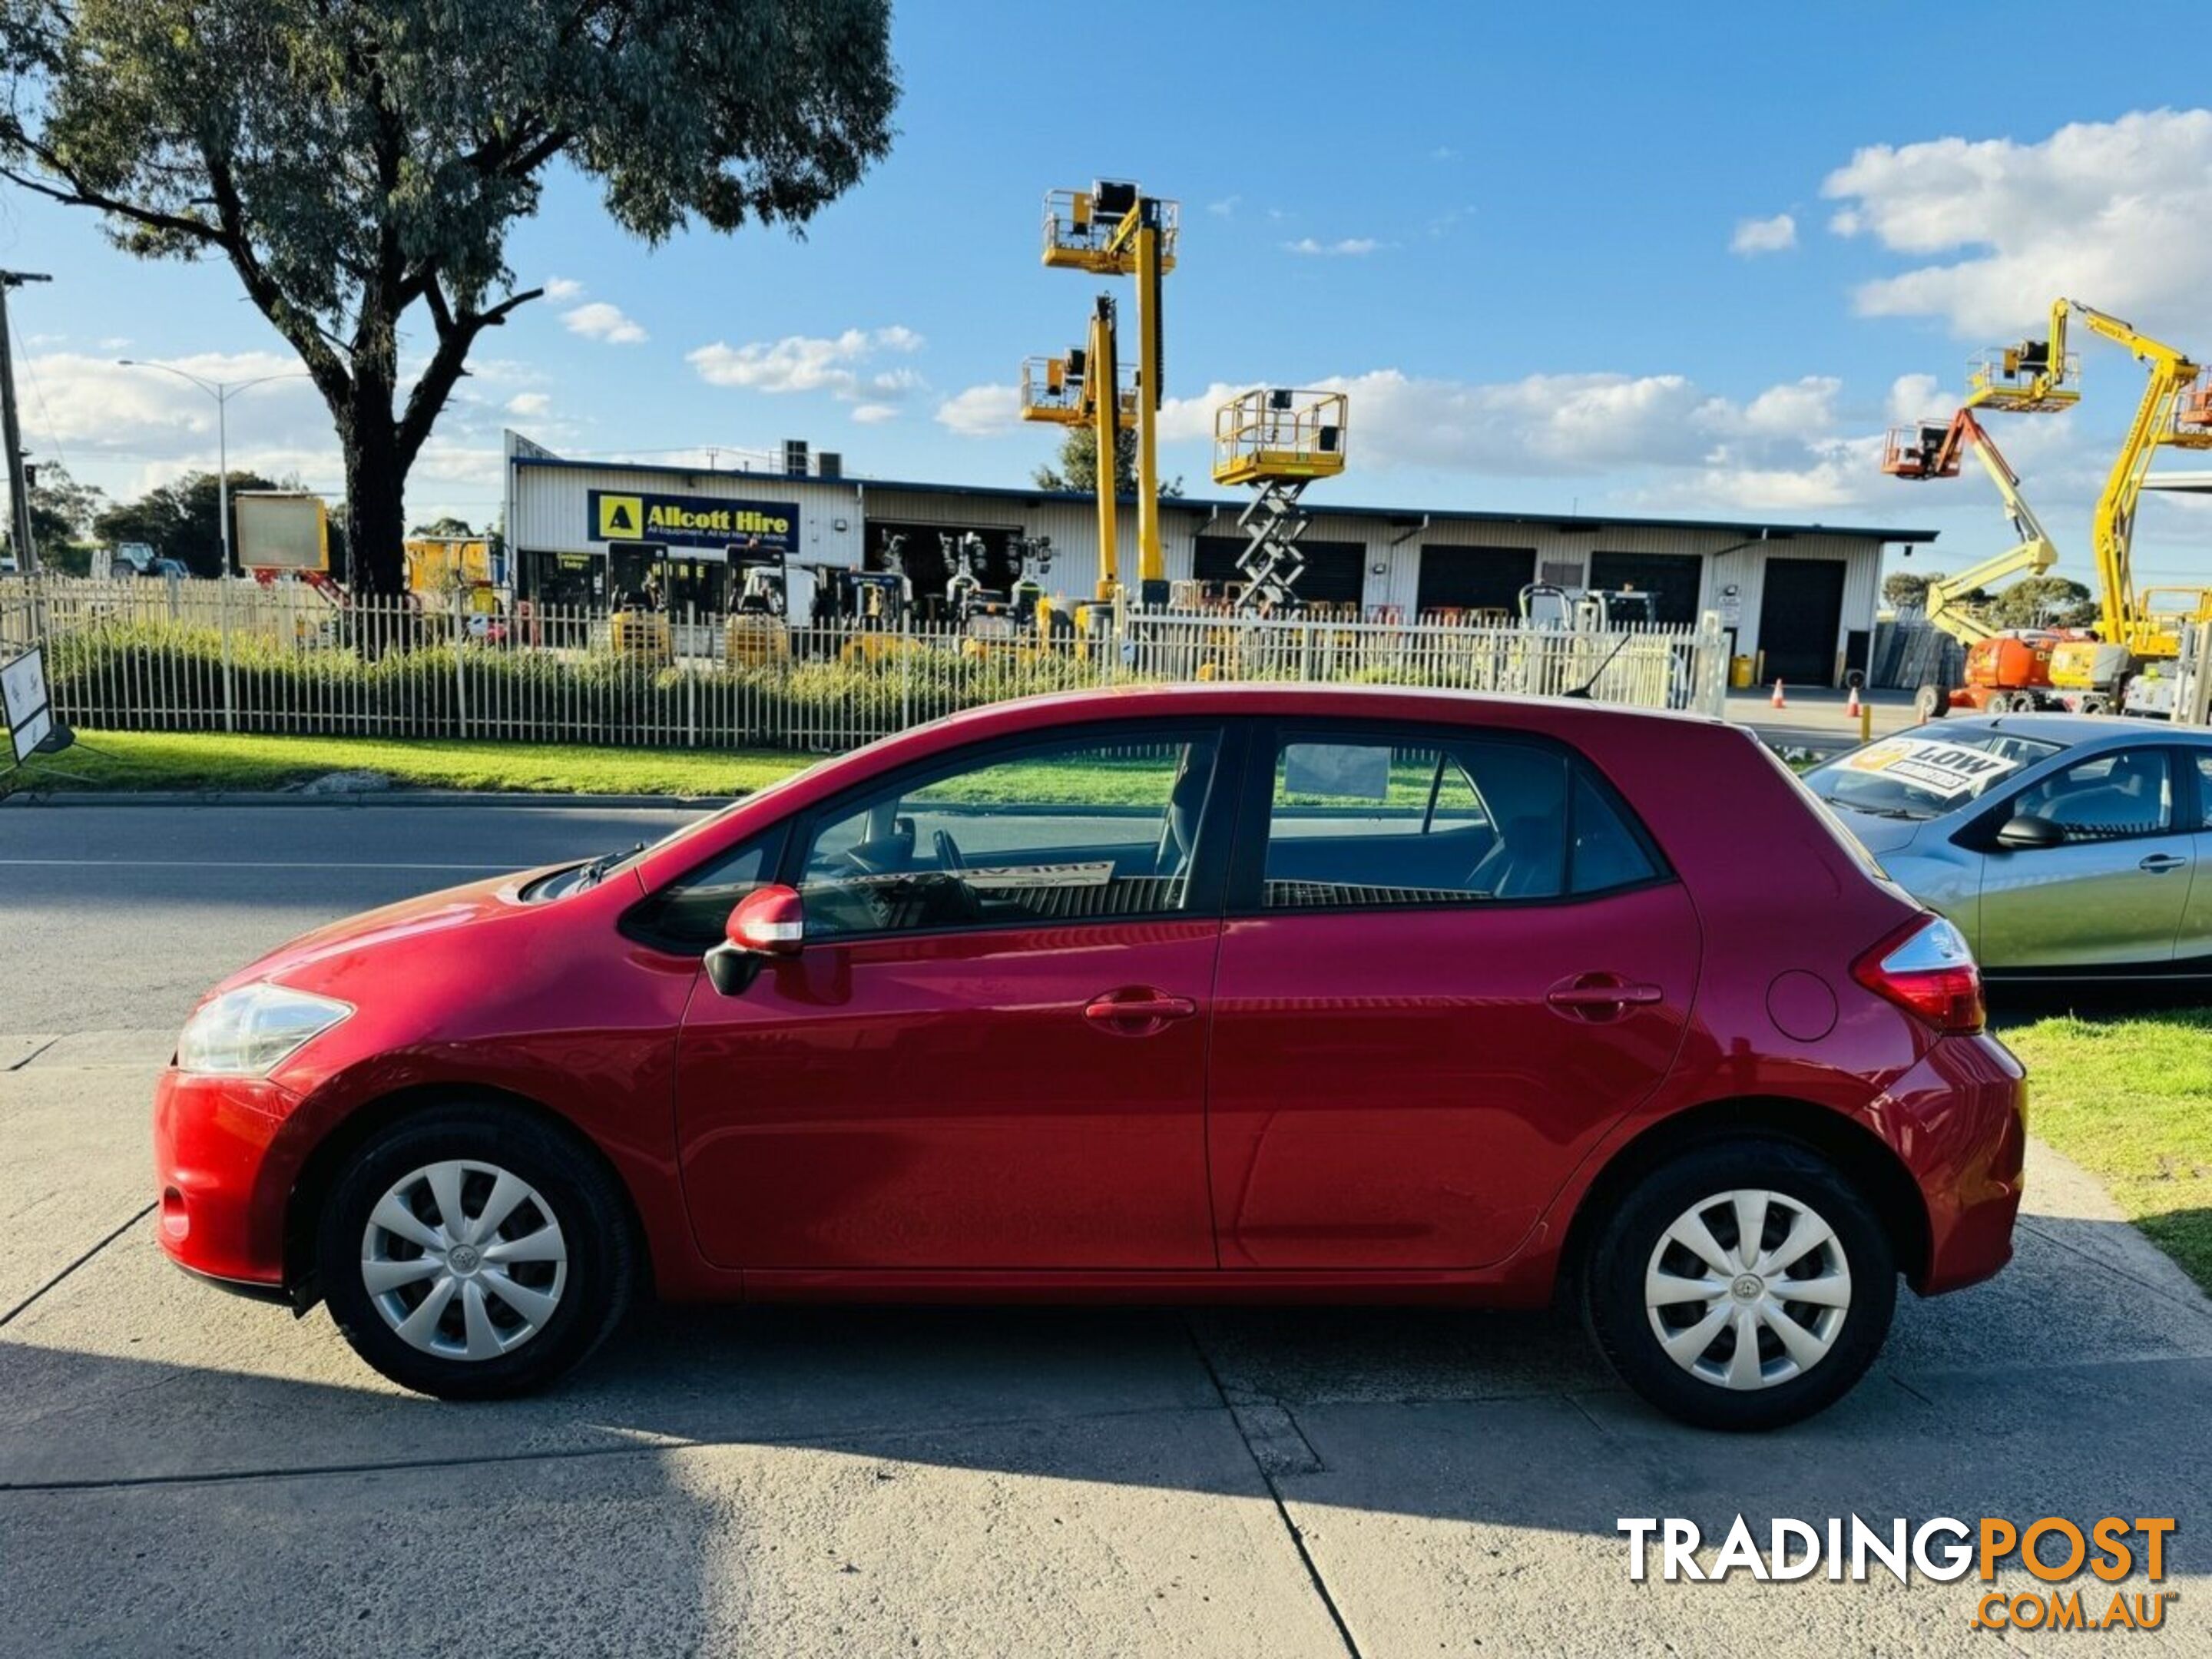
[0,807,2212,1659]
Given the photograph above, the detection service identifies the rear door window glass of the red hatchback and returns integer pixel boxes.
[1261,732,1661,909]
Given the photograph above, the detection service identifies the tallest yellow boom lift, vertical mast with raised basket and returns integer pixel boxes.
[1044,179,1181,606]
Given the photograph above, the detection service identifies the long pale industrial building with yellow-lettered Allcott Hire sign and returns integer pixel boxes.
[507,433,1936,686]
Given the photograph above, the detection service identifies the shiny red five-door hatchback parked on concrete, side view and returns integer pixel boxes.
[155,686,2024,1427]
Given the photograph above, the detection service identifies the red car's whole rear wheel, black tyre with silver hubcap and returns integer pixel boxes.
[1581,1137,1898,1429]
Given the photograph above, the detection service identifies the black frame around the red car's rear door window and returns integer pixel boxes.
[1217,714,1679,918]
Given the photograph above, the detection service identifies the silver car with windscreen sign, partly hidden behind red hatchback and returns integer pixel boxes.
[1805,714,2212,980]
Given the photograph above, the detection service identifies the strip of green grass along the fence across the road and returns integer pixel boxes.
[20,732,819,799]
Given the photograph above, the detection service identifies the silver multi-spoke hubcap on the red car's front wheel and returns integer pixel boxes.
[360,1159,568,1360]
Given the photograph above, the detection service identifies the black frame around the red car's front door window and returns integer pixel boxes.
[774,714,1245,945]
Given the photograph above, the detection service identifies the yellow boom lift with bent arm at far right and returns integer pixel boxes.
[1966,299,2212,714]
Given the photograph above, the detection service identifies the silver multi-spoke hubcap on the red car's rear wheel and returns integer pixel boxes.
[1644,1188,1852,1389]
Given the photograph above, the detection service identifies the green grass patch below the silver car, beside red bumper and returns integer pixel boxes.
[2002,1008,2212,1292]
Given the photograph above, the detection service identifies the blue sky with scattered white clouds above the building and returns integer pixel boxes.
[12,0,2212,580]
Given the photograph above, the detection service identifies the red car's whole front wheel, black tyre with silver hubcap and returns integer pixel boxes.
[316,1106,637,1400]
